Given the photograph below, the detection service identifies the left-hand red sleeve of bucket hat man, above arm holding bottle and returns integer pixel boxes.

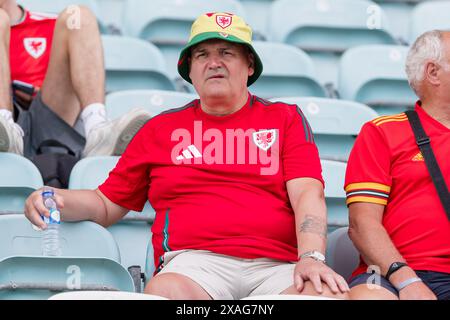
[99,122,154,211]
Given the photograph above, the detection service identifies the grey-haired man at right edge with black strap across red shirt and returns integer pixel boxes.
[345,31,450,300]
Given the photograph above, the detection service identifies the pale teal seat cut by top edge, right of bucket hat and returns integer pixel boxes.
[268,0,395,85]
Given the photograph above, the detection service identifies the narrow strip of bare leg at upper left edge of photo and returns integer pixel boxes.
[0,9,13,112]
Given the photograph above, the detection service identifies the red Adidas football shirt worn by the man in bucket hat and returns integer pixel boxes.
[99,95,323,267]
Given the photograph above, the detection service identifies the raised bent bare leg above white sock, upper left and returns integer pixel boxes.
[41,6,105,126]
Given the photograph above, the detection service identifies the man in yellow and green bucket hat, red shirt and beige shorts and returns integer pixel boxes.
[22,13,348,299]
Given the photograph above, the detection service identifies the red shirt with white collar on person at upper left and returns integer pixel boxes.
[9,10,56,87]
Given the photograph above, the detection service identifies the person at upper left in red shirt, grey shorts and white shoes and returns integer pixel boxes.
[0,0,150,157]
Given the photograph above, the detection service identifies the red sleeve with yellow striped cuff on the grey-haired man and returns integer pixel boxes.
[344,122,392,205]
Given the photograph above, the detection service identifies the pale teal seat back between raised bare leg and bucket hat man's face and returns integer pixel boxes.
[102,36,175,92]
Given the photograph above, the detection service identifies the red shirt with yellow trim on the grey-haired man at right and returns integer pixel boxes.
[345,103,450,276]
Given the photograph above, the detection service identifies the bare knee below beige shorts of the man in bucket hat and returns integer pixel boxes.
[144,273,211,300]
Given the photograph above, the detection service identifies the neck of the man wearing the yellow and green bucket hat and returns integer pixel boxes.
[200,90,248,117]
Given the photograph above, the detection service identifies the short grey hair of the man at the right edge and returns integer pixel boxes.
[406,30,447,97]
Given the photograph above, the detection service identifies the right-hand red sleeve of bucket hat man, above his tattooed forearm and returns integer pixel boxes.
[282,106,324,184]
